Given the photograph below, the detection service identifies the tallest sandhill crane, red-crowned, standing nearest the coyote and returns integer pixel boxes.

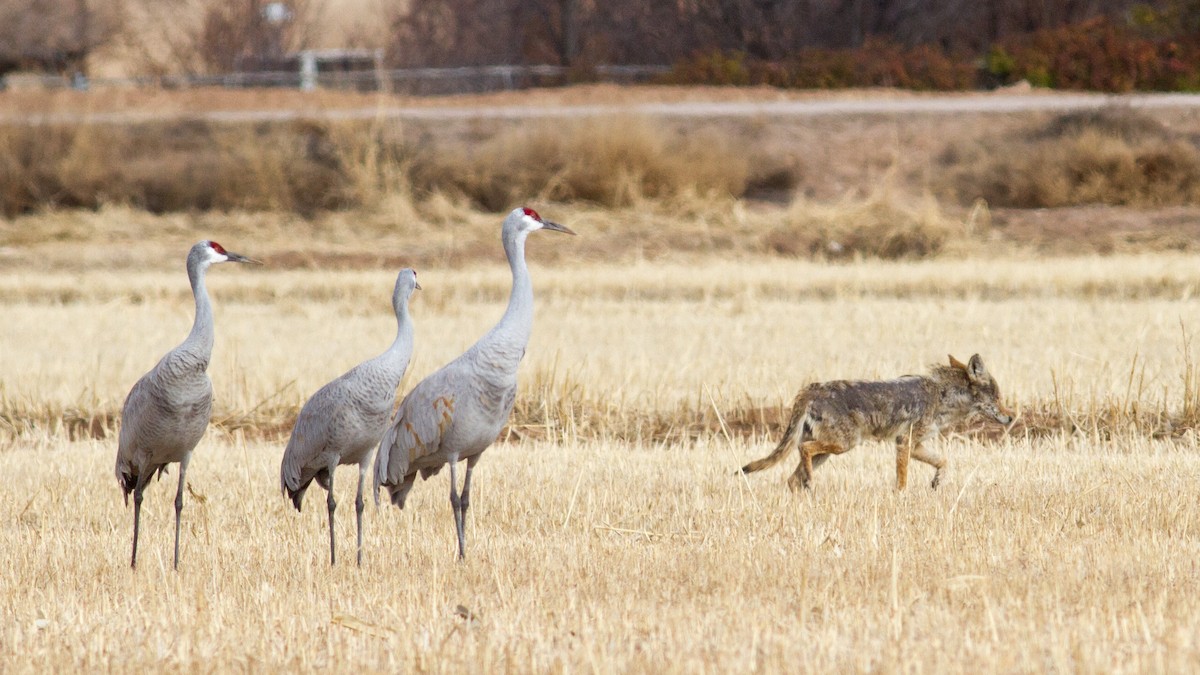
[374,208,575,558]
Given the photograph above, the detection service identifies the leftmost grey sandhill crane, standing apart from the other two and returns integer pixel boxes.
[116,241,262,569]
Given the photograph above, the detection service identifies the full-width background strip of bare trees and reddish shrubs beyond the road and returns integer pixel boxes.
[7,0,1200,91]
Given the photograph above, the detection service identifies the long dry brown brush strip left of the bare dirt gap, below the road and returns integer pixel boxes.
[0,114,772,216]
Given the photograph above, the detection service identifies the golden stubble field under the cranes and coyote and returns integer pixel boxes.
[0,236,1200,673]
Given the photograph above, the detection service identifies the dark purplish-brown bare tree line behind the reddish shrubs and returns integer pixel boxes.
[390,0,1185,66]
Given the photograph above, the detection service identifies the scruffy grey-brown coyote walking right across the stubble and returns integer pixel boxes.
[742,354,1013,490]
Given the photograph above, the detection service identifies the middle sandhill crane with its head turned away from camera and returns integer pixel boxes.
[280,269,421,567]
